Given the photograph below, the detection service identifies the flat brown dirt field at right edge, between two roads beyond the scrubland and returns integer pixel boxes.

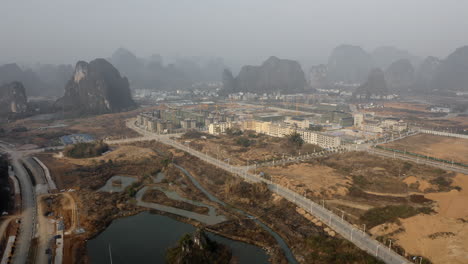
[384,134,468,164]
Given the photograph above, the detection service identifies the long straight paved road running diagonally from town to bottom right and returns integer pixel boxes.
[113,121,410,264]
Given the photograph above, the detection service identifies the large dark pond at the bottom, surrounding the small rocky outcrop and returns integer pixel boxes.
[87,212,268,264]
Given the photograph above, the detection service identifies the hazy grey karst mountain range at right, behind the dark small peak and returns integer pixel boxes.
[309,45,468,93]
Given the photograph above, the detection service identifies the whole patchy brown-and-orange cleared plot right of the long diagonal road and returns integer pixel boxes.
[257,152,468,263]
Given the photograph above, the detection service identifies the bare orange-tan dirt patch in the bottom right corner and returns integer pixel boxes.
[376,174,468,264]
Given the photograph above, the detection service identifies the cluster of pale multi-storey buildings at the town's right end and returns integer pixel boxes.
[353,113,408,133]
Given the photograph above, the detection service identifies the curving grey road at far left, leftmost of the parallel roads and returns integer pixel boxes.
[0,143,37,264]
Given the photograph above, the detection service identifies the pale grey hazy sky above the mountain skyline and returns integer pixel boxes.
[0,0,468,66]
